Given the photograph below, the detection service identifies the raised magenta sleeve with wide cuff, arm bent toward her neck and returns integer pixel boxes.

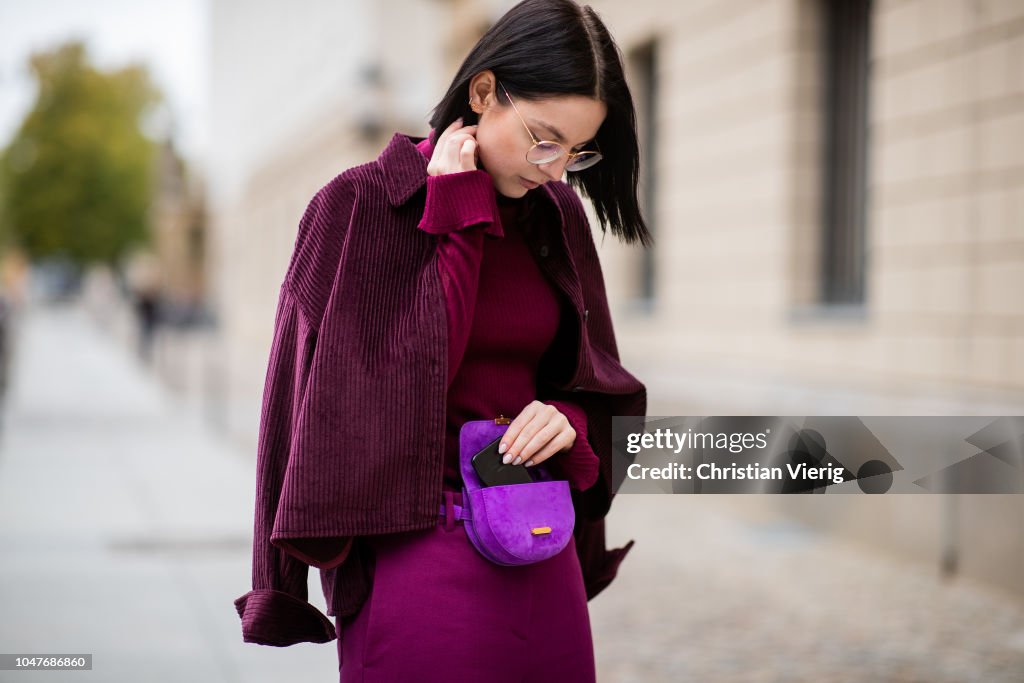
[419,169,505,386]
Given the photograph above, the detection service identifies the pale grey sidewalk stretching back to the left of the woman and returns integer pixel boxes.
[0,306,338,683]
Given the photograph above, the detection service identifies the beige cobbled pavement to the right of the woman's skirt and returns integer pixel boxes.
[590,495,1024,683]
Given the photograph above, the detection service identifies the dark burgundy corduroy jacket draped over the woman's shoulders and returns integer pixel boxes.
[234,133,646,646]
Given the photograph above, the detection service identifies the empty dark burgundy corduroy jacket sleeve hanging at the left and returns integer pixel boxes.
[234,281,352,646]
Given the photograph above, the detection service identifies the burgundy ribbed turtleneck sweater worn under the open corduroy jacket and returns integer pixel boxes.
[407,137,599,490]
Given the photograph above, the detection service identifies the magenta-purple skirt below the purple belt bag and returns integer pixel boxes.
[335,493,595,683]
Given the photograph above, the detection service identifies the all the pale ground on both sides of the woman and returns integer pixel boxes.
[0,301,1024,683]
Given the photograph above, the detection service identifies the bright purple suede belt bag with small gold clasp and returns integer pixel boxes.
[450,420,575,566]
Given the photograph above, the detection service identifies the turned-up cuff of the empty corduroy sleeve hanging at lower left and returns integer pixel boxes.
[234,589,337,647]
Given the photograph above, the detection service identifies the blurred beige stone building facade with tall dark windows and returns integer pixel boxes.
[210,0,1024,593]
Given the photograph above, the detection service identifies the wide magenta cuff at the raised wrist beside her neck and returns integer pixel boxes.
[419,169,505,238]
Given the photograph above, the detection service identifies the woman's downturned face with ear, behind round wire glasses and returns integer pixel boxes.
[470,72,607,198]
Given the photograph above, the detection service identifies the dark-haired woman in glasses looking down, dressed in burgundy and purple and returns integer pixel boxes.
[236,0,650,682]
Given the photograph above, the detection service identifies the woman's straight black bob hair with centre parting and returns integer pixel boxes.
[430,0,653,246]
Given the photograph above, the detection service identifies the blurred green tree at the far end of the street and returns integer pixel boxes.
[0,42,163,266]
